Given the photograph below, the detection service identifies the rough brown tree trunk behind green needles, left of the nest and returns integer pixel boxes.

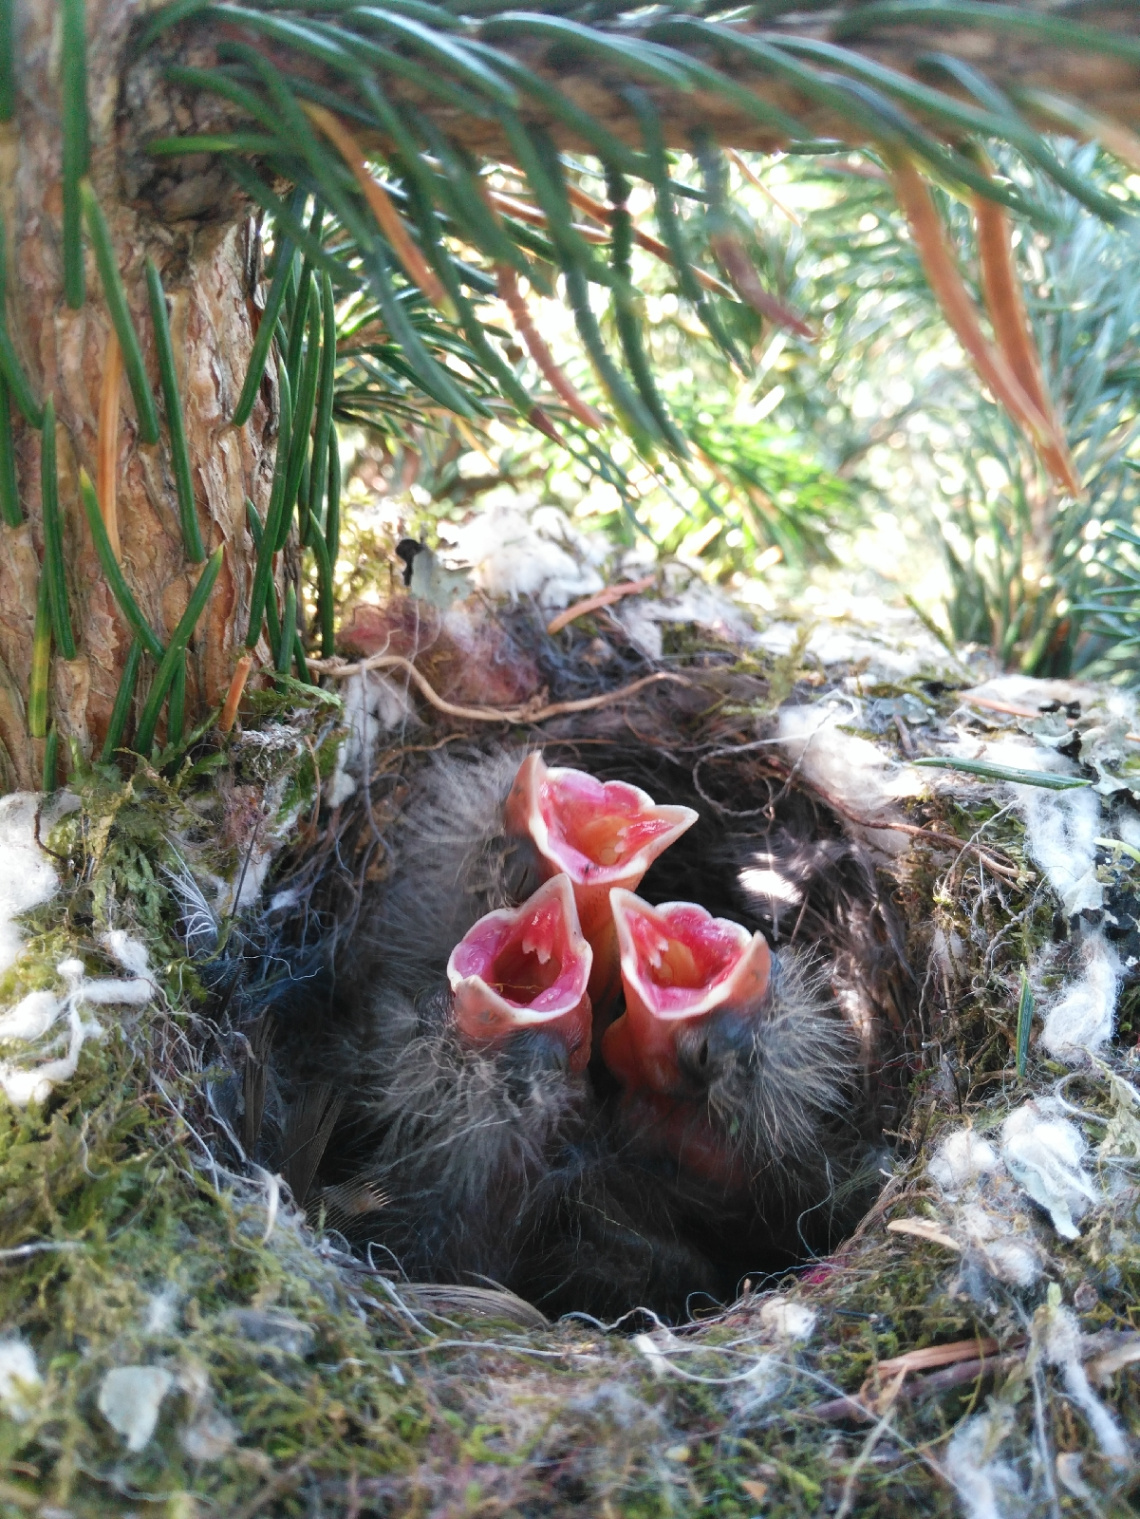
[0,0,275,787]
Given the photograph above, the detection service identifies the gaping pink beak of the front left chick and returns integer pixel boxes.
[447,875,593,1071]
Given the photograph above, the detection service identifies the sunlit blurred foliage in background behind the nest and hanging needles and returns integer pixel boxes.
[262,133,1140,677]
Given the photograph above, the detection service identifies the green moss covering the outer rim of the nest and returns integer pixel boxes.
[0,653,1140,1519]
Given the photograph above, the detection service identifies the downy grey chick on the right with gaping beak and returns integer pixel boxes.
[602,890,853,1198]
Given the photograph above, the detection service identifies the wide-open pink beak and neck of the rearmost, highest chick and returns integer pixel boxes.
[505,753,698,1012]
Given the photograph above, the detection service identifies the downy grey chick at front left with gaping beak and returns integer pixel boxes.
[333,876,593,1287]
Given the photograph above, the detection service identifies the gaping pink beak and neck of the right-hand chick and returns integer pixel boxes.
[602,890,772,1097]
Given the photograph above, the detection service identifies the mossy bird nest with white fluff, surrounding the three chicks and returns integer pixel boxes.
[0,586,1140,1516]
